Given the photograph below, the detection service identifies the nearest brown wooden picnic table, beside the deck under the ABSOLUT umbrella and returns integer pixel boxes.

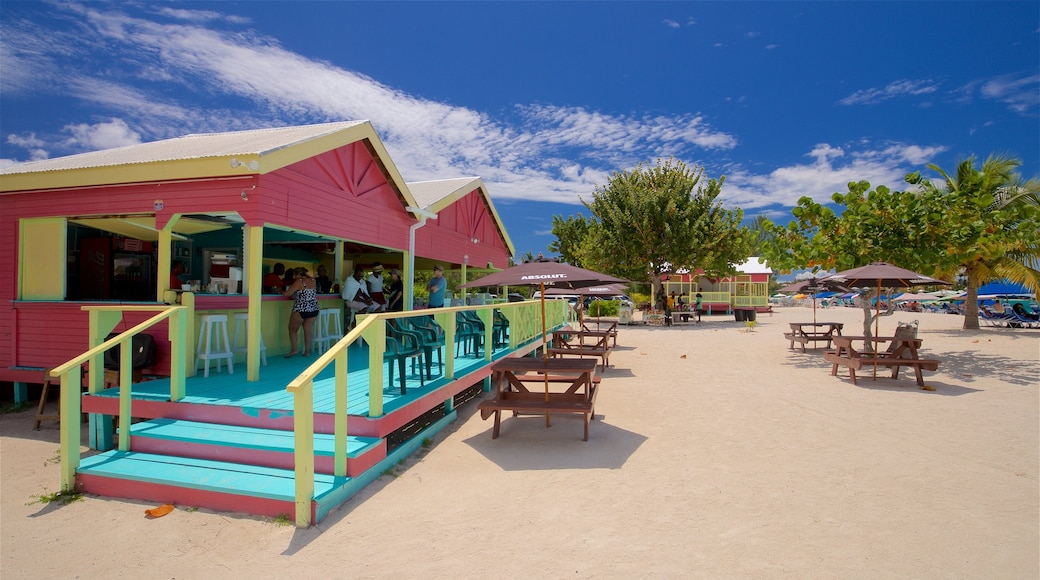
[477,357,597,441]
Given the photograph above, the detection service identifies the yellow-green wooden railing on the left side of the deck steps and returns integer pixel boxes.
[51,305,190,492]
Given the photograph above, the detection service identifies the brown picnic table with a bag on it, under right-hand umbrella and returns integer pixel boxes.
[824,337,939,387]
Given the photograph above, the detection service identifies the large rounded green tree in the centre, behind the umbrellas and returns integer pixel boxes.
[579,159,750,305]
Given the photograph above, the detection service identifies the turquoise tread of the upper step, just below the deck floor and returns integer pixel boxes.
[130,419,382,457]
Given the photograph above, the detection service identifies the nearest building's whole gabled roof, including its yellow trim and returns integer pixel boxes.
[0,121,414,213]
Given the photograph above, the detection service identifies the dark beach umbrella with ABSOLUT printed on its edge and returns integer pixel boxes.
[462,259,628,425]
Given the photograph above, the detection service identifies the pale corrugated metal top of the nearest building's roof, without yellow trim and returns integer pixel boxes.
[0,121,367,175]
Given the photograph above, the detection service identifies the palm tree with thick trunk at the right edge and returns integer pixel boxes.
[906,156,1040,329]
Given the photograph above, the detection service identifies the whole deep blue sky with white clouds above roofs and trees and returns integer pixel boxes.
[0,0,1040,255]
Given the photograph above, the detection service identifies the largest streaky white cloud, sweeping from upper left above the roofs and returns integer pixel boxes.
[5,4,736,204]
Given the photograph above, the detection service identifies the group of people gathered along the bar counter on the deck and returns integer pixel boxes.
[282,262,447,359]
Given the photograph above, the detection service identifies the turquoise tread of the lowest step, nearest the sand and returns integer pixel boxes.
[77,451,350,502]
